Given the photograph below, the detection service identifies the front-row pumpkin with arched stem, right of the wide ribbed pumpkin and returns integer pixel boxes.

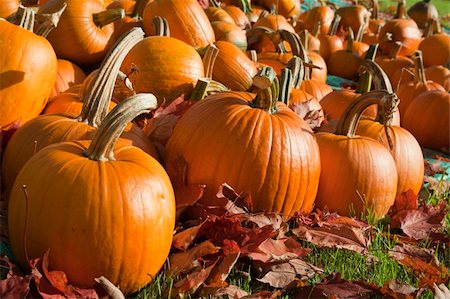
[316,92,398,218]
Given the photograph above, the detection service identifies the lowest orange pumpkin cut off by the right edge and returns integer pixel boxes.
[402,90,450,153]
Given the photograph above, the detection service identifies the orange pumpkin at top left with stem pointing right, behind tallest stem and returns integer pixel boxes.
[39,0,119,67]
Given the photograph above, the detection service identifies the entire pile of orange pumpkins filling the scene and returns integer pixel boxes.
[0,0,450,295]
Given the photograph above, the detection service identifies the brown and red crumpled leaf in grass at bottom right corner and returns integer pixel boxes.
[389,244,450,288]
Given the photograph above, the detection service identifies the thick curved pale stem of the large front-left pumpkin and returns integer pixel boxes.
[84,93,158,161]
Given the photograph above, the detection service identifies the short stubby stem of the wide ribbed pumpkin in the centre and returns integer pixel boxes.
[250,67,280,114]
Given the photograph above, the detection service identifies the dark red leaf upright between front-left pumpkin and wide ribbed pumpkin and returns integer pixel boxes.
[166,156,205,214]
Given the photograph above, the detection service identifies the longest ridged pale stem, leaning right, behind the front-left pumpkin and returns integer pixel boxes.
[77,27,144,127]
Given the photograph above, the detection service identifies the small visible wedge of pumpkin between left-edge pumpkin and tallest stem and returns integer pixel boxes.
[50,59,86,99]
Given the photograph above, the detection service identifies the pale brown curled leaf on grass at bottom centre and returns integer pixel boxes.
[257,259,323,288]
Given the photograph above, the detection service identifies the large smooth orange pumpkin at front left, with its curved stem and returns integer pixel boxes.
[8,95,175,295]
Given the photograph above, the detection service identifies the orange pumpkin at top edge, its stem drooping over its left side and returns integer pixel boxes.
[143,0,215,49]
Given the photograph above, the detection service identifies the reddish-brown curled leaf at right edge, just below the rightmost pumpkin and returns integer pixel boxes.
[391,201,447,240]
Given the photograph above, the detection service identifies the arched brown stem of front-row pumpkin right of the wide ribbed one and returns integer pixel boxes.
[335,90,396,137]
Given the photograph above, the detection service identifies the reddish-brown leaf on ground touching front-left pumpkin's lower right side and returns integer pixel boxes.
[169,241,219,276]
